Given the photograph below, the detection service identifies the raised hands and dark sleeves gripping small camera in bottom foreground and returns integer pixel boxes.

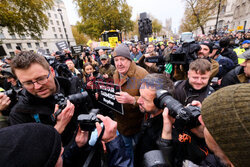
[63,115,132,167]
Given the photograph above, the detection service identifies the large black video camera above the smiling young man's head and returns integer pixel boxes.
[170,42,201,65]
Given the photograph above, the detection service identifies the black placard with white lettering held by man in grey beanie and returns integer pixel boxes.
[95,81,124,115]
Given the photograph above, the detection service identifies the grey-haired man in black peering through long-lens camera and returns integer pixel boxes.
[135,74,173,167]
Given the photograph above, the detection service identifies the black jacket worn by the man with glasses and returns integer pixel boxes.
[9,77,92,145]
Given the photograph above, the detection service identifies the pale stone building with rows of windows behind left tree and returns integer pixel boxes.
[0,0,75,56]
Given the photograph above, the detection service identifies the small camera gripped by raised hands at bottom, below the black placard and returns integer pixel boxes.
[77,109,102,132]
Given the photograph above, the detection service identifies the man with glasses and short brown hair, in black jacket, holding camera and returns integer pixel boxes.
[10,51,92,145]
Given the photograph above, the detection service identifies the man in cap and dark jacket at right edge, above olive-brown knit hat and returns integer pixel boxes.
[221,49,250,87]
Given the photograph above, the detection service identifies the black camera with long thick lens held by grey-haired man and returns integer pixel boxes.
[154,90,201,129]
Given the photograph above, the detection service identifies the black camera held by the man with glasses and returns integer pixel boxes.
[51,92,88,122]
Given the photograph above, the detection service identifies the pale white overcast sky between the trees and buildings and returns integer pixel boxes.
[63,0,184,31]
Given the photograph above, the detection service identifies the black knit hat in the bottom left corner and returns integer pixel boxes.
[0,123,61,167]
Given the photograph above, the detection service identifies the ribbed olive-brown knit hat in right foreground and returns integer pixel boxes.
[201,84,250,166]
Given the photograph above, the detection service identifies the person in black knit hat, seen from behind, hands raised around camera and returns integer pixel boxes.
[0,115,131,167]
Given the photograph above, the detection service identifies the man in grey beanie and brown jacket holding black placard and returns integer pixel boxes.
[113,44,148,163]
